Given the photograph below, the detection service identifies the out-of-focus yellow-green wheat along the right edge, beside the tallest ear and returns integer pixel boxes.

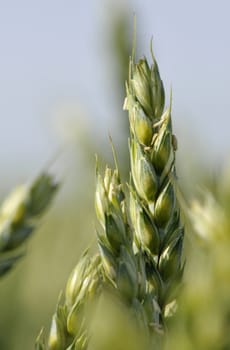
[166,168,230,350]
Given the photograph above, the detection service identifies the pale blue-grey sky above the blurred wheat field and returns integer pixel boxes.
[0,0,230,182]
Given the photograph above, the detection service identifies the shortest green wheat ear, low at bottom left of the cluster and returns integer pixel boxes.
[35,250,101,350]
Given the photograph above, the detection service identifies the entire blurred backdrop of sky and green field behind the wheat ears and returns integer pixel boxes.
[0,0,230,350]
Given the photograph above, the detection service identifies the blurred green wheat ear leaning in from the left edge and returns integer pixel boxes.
[0,173,58,277]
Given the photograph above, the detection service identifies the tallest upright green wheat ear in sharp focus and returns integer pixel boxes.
[124,48,184,328]
